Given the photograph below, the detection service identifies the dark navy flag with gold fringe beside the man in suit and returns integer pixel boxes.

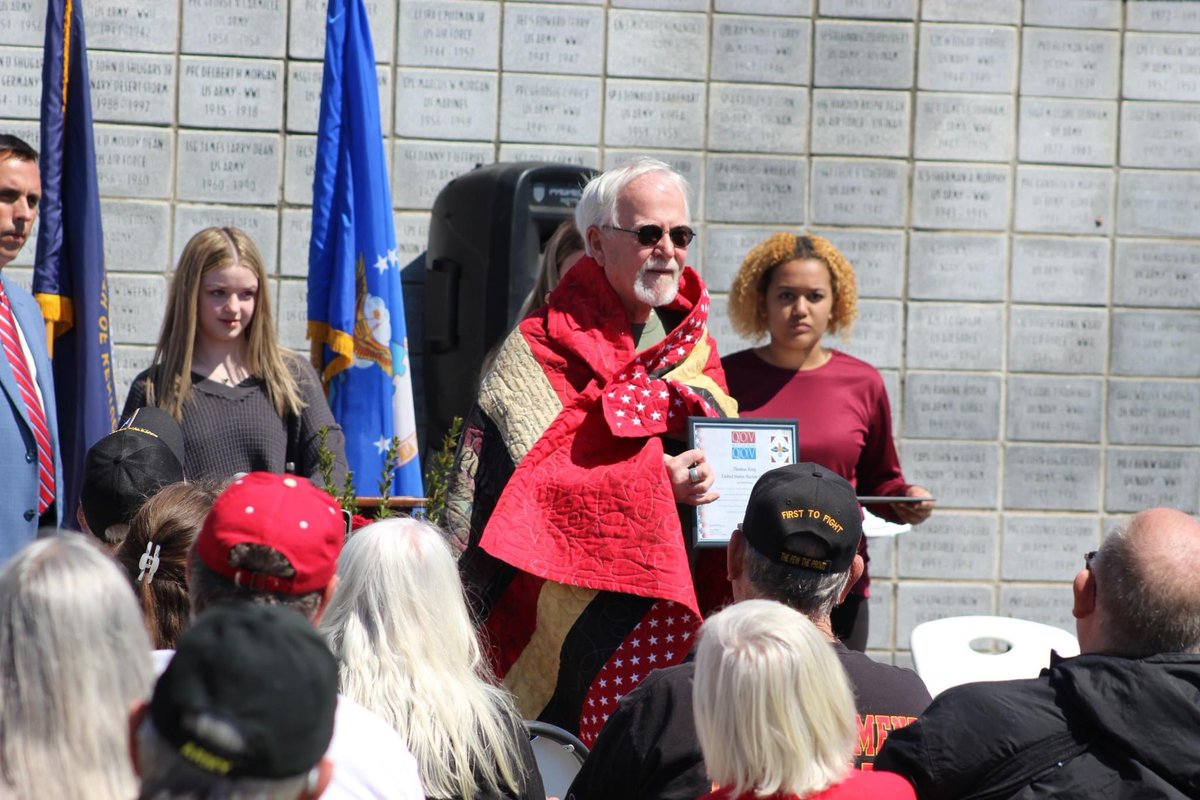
[34,0,116,524]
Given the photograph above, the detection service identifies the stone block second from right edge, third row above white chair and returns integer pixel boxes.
[1004,444,1100,510]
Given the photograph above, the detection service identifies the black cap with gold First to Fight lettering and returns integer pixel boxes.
[742,462,863,573]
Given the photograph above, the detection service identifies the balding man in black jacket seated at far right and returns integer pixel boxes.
[875,509,1200,800]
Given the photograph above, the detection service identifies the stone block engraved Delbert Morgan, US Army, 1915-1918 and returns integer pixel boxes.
[179,55,284,131]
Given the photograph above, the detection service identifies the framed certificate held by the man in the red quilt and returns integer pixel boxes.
[688,416,797,547]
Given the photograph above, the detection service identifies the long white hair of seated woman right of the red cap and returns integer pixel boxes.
[320,518,527,798]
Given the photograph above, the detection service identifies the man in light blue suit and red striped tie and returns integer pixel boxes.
[0,134,62,563]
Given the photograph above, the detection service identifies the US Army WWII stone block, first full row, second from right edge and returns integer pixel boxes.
[1021,28,1121,100]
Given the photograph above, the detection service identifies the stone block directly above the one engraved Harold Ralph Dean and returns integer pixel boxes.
[812,22,916,89]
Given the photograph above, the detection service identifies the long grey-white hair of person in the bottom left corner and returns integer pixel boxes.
[0,533,152,800]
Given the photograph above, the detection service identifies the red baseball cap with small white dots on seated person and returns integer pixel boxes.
[196,473,346,595]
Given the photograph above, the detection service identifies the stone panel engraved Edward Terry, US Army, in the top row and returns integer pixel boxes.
[503,2,604,76]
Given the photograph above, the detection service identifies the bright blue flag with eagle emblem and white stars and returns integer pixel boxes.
[308,0,422,497]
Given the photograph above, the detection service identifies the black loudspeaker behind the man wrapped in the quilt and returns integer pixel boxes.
[425,162,595,449]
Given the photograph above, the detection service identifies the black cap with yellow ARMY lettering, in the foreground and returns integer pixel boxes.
[150,602,337,778]
